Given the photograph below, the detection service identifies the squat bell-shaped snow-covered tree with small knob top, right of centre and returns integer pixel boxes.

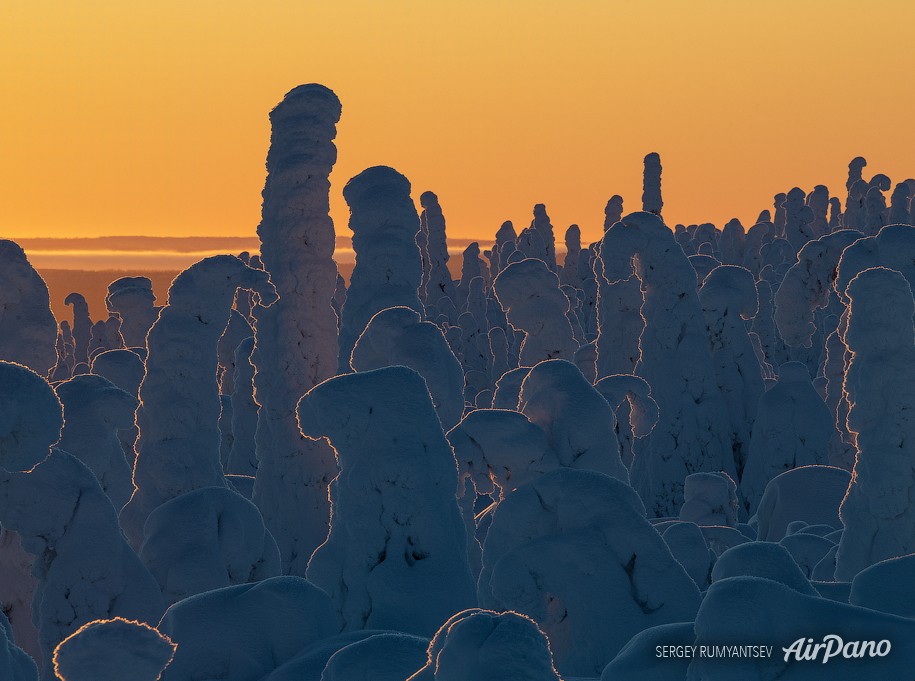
[740,362,835,515]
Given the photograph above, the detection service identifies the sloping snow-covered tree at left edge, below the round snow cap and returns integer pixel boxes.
[0,446,164,678]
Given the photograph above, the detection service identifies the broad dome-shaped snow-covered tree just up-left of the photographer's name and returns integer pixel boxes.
[478,468,699,676]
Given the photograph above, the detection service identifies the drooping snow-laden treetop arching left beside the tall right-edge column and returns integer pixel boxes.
[775,229,864,348]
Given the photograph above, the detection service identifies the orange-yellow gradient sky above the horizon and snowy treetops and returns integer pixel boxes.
[0,0,915,244]
